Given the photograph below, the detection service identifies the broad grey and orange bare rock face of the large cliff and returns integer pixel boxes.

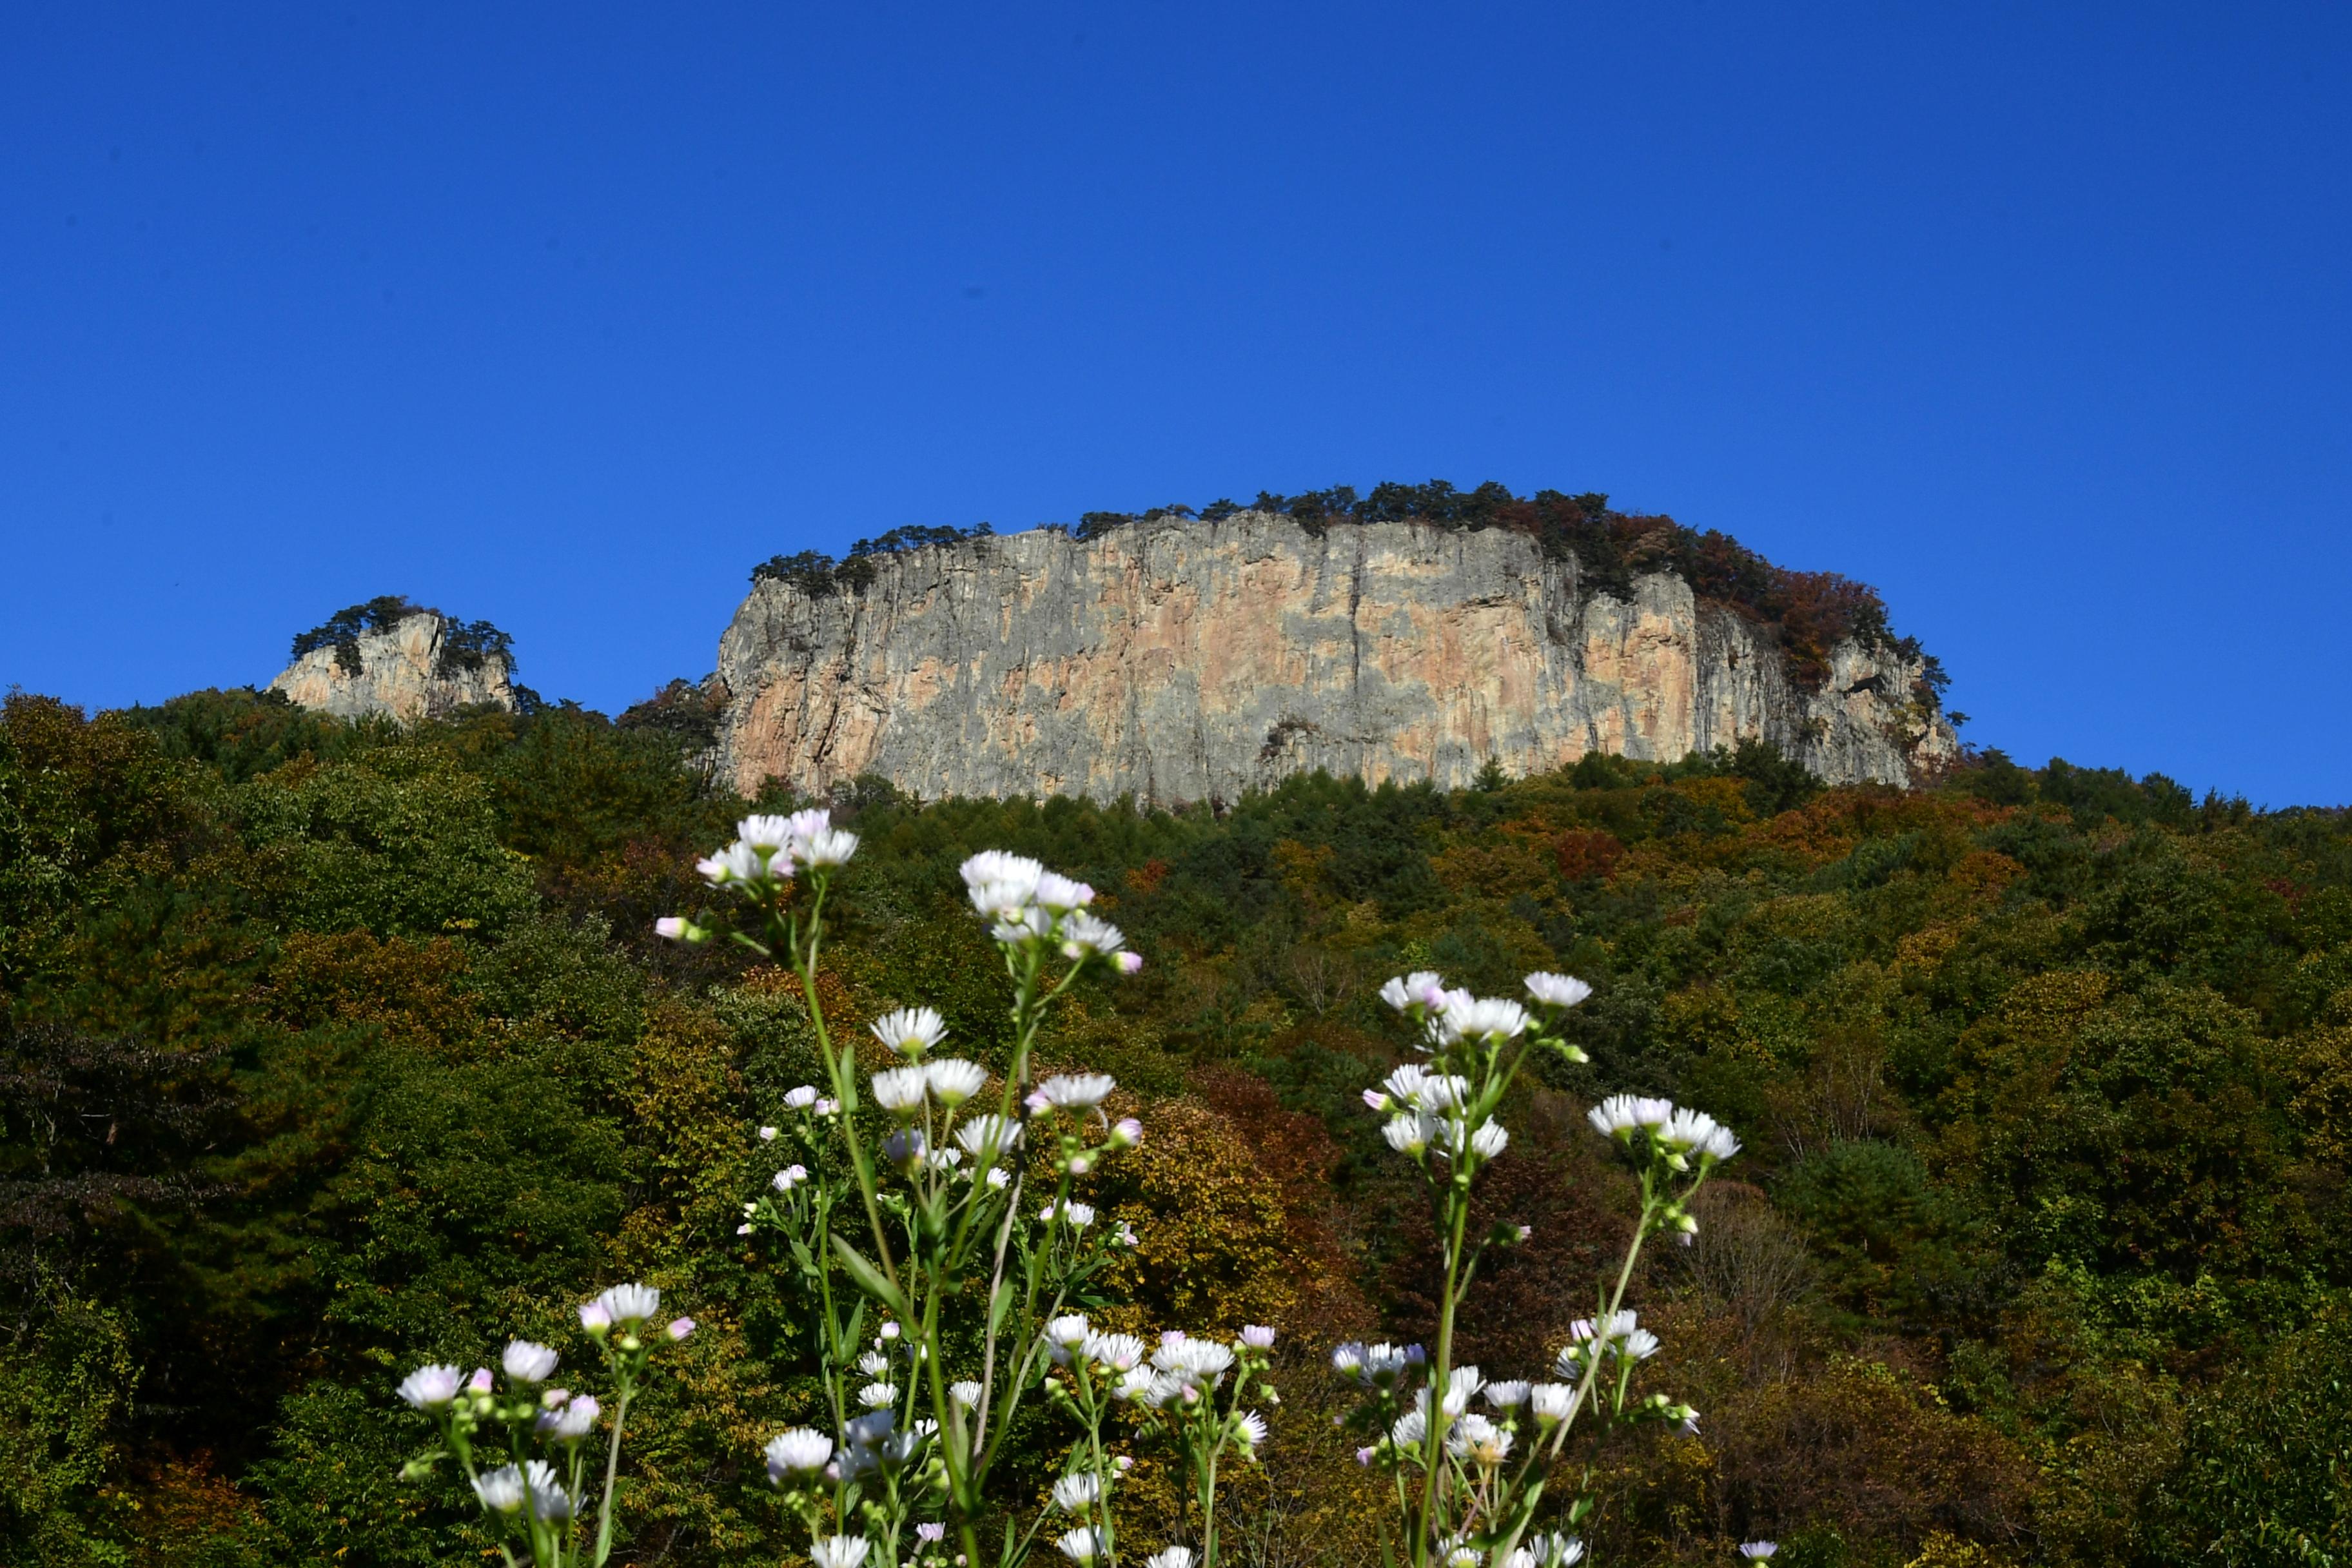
[715,513,1957,804]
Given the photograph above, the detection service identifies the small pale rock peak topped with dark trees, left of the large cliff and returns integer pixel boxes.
[271,594,515,724]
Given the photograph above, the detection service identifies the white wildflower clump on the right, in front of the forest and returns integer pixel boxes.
[1331,974,1741,1568]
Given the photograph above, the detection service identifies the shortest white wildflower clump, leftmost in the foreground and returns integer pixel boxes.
[398,1284,694,1568]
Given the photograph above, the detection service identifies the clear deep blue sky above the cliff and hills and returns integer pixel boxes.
[0,0,2352,804]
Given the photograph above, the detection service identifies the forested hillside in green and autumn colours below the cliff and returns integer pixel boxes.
[0,691,2352,1568]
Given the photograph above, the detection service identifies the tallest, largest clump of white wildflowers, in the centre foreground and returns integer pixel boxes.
[656,811,1275,1568]
